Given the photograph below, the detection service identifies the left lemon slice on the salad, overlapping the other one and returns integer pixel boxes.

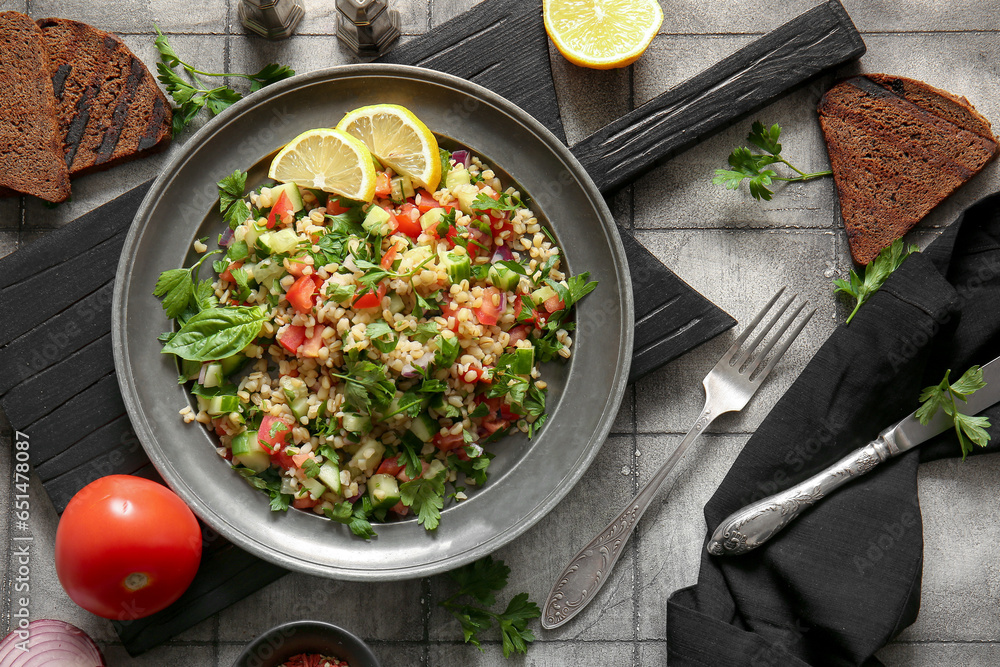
[267,129,375,202]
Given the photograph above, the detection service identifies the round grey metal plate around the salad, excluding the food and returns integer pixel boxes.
[112,65,633,581]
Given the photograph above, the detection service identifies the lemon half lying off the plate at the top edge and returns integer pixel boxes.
[543,0,663,69]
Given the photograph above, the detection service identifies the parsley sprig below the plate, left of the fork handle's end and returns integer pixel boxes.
[438,556,542,658]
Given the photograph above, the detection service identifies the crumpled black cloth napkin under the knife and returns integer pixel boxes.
[667,194,1000,667]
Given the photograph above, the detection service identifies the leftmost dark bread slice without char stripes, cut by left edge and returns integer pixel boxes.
[0,12,69,202]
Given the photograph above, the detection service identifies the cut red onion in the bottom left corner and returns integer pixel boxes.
[0,619,105,667]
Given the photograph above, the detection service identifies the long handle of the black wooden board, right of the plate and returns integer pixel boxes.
[573,0,865,193]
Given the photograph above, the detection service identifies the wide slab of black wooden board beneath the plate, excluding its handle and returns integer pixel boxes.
[0,0,853,655]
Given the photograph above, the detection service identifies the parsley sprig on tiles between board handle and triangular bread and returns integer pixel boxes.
[712,121,833,201]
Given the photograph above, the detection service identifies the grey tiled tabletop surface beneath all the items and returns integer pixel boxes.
[0,0,1000,667]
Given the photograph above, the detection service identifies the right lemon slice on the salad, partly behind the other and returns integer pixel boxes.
[337,104,441,192]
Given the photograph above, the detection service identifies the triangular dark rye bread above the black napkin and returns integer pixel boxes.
[818,74,997,264]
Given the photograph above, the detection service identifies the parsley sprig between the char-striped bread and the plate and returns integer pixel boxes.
[154,26,295,137]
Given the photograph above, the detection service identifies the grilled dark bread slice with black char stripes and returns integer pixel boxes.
[38,18,172,176]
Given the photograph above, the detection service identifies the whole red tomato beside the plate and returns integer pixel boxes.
[56,475,201,621]
